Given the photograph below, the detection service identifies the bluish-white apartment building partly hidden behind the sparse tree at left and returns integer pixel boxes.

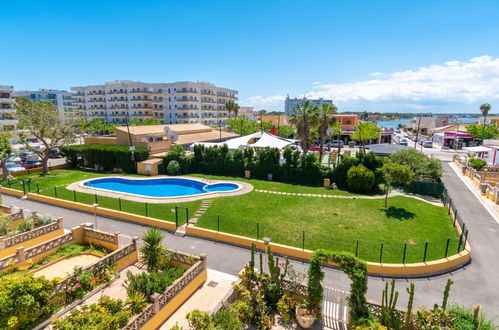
[14,88,76,118]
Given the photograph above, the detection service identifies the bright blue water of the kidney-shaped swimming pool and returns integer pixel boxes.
[84,178,239,197]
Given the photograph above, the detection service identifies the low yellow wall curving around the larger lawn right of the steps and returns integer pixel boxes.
[186,226,471,275]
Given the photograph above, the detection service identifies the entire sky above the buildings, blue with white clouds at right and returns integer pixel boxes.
[0,0,499,112]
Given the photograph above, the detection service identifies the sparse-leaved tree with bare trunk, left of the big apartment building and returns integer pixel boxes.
[16,97,76,175]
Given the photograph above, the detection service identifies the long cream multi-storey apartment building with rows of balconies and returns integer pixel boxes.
[71,80,237,125]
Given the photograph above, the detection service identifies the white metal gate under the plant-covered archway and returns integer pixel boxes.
[322,286,349,330]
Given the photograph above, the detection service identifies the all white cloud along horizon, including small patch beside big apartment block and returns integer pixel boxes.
[248,56,499,112]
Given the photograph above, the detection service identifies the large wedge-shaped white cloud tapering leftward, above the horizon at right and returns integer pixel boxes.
[306,56,499,103]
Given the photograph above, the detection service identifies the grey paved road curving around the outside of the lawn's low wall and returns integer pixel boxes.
[4,163,499,316]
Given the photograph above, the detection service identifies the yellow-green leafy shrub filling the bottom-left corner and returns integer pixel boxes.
[0,274,57,329]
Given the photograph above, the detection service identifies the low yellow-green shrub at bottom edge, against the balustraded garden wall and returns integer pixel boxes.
[53,296,132,330]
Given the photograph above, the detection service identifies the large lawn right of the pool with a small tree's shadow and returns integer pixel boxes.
[190,176,458,262]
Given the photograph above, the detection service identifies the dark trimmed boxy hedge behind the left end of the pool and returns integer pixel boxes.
[61,145,149,173]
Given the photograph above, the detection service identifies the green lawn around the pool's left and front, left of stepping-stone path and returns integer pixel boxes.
[0,170,201,224]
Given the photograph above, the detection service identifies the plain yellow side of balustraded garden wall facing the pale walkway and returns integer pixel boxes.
[142,268,208,330]
